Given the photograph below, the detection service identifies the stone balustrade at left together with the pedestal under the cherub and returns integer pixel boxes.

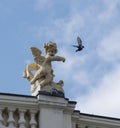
[0,93,76,128]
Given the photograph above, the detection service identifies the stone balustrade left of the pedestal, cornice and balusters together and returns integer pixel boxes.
[0,94,38,128]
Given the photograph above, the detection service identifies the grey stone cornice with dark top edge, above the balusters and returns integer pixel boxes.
[0,93,38,109]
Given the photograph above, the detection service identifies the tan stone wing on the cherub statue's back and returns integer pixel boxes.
[30,47,45,65]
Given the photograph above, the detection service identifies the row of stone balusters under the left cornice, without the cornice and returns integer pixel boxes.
[0,107,37,128]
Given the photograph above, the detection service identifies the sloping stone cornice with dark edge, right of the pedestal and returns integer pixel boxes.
[72,110,120,128]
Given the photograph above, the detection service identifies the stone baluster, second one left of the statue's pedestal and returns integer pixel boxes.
[19,110,26,128]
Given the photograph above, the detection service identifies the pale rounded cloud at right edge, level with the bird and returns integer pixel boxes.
[98,29,120,62]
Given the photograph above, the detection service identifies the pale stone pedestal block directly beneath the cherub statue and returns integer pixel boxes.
[38,94,76,128]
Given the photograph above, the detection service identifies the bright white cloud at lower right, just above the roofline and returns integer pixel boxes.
[76,65,120,117]
